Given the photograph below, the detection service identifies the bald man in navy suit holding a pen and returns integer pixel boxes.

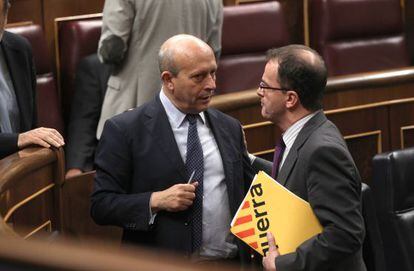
[91,35,254,261]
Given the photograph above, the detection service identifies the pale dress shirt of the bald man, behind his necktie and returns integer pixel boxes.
[160,90,237,259]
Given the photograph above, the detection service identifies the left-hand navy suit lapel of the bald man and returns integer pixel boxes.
[145,98,188,180]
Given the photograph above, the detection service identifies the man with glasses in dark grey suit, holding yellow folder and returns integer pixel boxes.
[257,45,365,271]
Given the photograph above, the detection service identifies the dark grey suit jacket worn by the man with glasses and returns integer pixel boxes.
[275,112,365,271]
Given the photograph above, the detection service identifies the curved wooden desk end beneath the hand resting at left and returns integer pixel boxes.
[0,148,64,238]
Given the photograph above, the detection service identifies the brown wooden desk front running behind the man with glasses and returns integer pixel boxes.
[212,67,414,183]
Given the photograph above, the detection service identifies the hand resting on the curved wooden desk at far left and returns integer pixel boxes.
[17,127,65,149]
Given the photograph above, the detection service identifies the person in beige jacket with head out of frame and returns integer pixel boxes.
[97,0,223,138]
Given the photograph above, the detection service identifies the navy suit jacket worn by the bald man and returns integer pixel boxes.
[91,95,254,257]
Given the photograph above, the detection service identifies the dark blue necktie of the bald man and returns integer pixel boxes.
[185,114,204,252]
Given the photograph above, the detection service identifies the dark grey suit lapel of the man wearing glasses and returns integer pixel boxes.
[277,111,326,186]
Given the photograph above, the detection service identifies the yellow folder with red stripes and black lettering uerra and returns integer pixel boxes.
[230,171,322,255]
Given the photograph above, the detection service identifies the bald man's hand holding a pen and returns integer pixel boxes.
[150,182,198,213]
